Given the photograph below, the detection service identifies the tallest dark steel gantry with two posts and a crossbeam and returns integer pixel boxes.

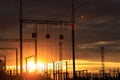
[19,0,76,80]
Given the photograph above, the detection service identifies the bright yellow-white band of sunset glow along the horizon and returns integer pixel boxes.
[7,59,120,73]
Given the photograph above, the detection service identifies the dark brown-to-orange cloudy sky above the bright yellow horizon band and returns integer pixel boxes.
[0,0,120,71]
